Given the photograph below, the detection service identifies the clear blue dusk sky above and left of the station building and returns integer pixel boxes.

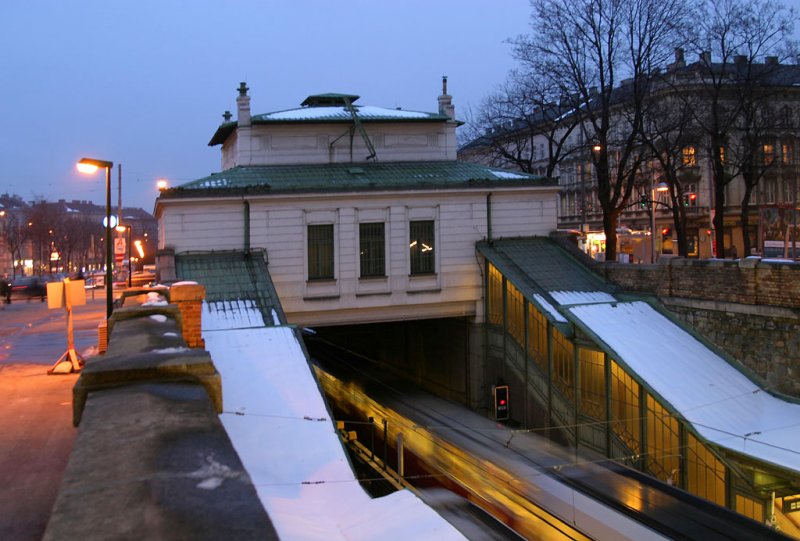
[0,0,530,211]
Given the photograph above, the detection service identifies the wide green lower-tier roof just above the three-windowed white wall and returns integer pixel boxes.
[160,161,558,199]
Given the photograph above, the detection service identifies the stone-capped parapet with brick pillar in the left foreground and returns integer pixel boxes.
[44,285,278,541]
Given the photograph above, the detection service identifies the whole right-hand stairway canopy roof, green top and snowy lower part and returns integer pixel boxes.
[478,238,800,472]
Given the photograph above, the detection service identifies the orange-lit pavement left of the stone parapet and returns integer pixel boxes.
[0,295,105,541]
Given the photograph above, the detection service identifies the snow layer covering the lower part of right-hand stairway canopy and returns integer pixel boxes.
[568,301,800,471]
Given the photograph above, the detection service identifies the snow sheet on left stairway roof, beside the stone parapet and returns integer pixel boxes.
[202,301,464,541]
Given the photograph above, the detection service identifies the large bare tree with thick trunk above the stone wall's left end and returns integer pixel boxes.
[514,0,687,259]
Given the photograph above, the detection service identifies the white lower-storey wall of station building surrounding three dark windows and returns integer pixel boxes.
[159,187,557,325]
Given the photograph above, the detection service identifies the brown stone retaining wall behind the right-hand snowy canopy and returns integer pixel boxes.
[595,257,800,397]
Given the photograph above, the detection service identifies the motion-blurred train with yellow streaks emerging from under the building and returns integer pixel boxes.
[305,335,789,541]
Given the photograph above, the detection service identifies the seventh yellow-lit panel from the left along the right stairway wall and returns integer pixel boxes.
[647,394,681,484]
